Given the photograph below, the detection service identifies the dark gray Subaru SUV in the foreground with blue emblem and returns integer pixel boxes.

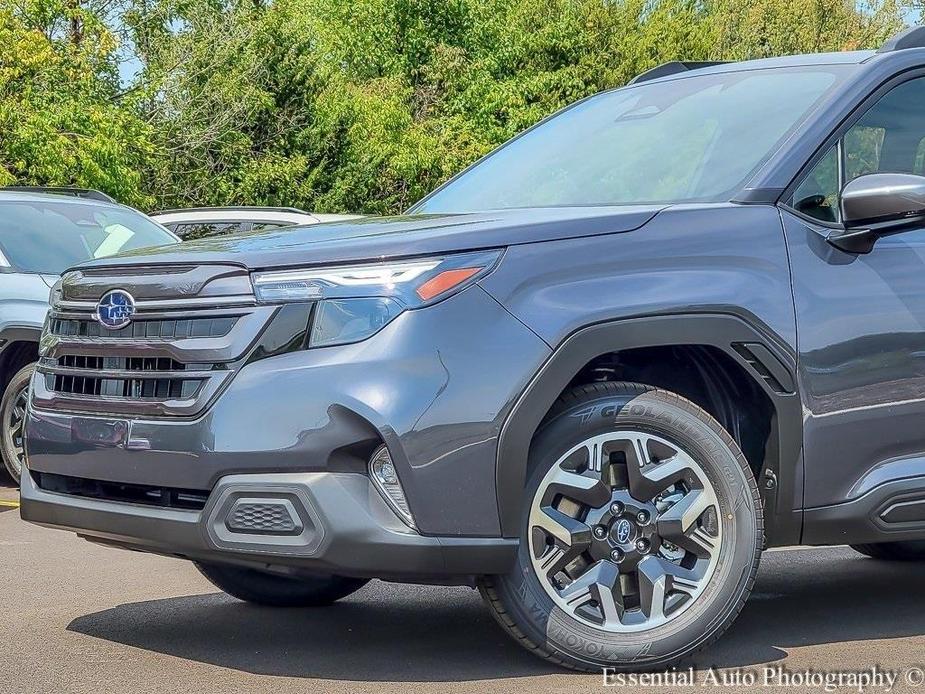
[22,30,925,669]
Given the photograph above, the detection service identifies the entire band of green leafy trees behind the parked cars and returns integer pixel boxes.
[0,0,910,213]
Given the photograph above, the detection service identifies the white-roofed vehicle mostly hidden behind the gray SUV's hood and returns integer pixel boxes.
[151,206,358,241]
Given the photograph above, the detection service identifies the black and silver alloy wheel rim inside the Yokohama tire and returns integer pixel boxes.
[528,431,722,632]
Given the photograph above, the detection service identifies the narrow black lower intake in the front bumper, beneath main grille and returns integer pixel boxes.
[31,472,209,511]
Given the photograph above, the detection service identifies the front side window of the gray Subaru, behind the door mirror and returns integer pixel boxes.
[790,78,925,222]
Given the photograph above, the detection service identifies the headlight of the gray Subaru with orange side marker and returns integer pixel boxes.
[251,251,501,347]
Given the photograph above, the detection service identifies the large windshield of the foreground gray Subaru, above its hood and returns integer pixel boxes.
[412,65,846,213]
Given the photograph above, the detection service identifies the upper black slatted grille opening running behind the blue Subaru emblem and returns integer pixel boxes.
[50,316,238,340]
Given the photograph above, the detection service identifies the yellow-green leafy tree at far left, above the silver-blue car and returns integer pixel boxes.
[0,0,152,206]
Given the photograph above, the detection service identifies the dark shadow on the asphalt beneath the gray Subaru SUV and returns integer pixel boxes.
[68,549,925,682]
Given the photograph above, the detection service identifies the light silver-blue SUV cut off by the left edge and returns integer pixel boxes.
[0,187,178,482]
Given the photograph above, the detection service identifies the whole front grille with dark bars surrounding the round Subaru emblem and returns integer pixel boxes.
[32,265,258,418]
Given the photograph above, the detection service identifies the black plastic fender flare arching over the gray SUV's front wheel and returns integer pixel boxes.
[495,313,803,545]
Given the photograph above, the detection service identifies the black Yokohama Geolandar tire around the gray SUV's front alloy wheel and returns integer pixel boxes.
[480,383,763,672]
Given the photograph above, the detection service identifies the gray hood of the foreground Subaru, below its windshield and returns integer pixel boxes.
[80,205,665,270]
